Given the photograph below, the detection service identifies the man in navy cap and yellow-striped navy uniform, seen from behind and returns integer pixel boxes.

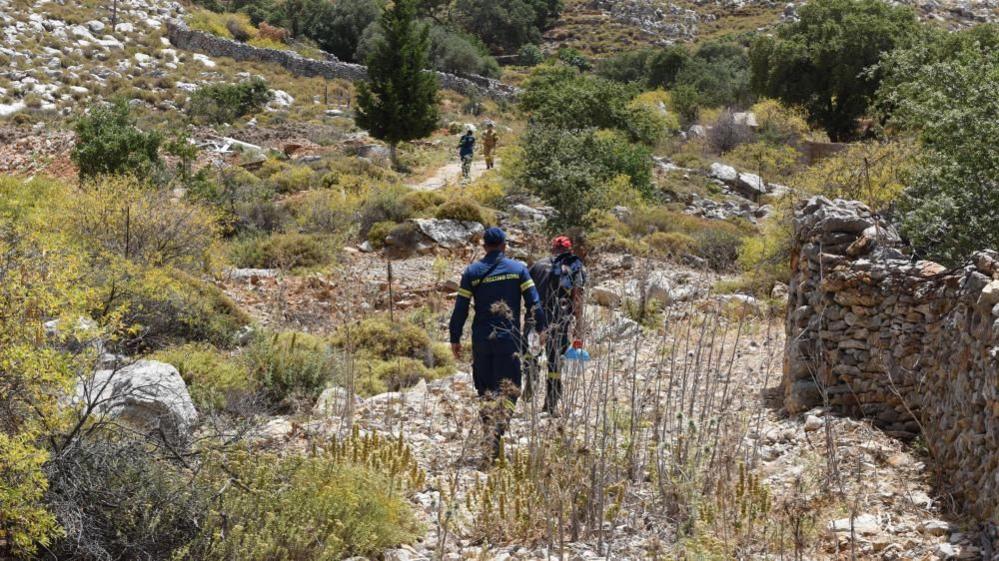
[450,228,546,458]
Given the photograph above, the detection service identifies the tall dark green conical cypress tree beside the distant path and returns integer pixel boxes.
[357,0,438,168]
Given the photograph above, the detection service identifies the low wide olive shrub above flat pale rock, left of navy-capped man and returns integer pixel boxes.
[231,232,334,270]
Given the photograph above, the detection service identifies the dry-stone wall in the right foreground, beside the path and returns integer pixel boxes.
[783,197,999,520]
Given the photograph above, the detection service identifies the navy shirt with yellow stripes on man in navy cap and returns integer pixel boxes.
[450,251,546,343]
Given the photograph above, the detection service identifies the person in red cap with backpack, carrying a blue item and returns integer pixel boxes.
[524,236,586,416]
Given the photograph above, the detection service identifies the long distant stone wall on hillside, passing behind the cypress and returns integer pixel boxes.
[167,20,518,100]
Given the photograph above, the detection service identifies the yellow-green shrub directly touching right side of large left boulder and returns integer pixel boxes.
[151,343,258,411]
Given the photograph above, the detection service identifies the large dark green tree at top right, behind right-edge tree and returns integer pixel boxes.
[750,0,919,140]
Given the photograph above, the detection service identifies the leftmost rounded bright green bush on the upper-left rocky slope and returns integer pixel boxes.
[71,100,161,178]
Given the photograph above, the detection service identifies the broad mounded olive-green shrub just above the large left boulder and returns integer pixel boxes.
[113,268,250,349]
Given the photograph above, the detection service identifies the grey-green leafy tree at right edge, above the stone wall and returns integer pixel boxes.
[879,26,999,265]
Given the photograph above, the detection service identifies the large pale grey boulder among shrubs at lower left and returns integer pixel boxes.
[83,360,198,435]
